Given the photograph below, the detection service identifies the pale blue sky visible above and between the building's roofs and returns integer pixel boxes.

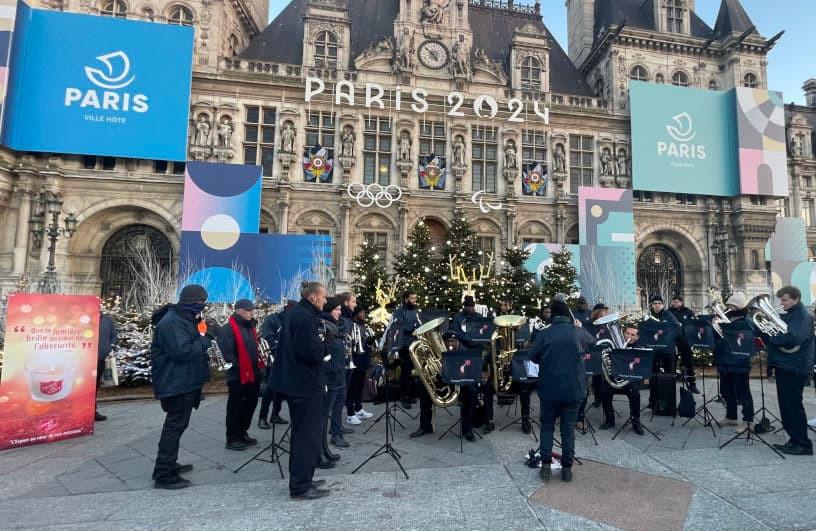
[269,0,816,104]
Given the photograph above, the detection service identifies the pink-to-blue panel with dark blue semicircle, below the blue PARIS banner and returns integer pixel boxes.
[181,162,261,235]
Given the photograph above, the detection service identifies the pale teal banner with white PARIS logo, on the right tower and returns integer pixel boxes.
[629,81,740,196]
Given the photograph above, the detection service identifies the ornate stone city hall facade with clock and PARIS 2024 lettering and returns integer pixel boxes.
[0,0,804,307]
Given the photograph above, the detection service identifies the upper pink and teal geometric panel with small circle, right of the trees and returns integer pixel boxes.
[578,186,635,247]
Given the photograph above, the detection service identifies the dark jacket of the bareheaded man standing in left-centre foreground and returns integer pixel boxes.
[271,299,328,398]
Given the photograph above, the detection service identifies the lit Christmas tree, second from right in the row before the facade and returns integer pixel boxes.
[485,247,540,316]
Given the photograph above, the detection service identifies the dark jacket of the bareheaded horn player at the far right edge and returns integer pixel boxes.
[762,301,814,376]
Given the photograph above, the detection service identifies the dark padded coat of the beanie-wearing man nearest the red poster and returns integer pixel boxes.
[150,305,211,400]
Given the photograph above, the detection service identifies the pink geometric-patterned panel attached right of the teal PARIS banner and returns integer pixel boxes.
[736,87,788,197]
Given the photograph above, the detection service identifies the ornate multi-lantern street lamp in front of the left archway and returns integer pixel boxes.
[29,188,79,293]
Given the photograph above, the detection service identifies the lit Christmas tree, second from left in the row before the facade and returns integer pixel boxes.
[394,220,439,308]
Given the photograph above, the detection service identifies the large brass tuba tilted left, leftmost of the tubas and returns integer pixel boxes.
[408,317,459,408]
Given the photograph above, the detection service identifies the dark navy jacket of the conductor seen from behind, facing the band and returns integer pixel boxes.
[530,316,594,402]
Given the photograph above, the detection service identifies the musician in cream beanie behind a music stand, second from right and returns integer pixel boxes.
[714,292,754,426]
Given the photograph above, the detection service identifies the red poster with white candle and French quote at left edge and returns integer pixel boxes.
[0,293,99,450]
